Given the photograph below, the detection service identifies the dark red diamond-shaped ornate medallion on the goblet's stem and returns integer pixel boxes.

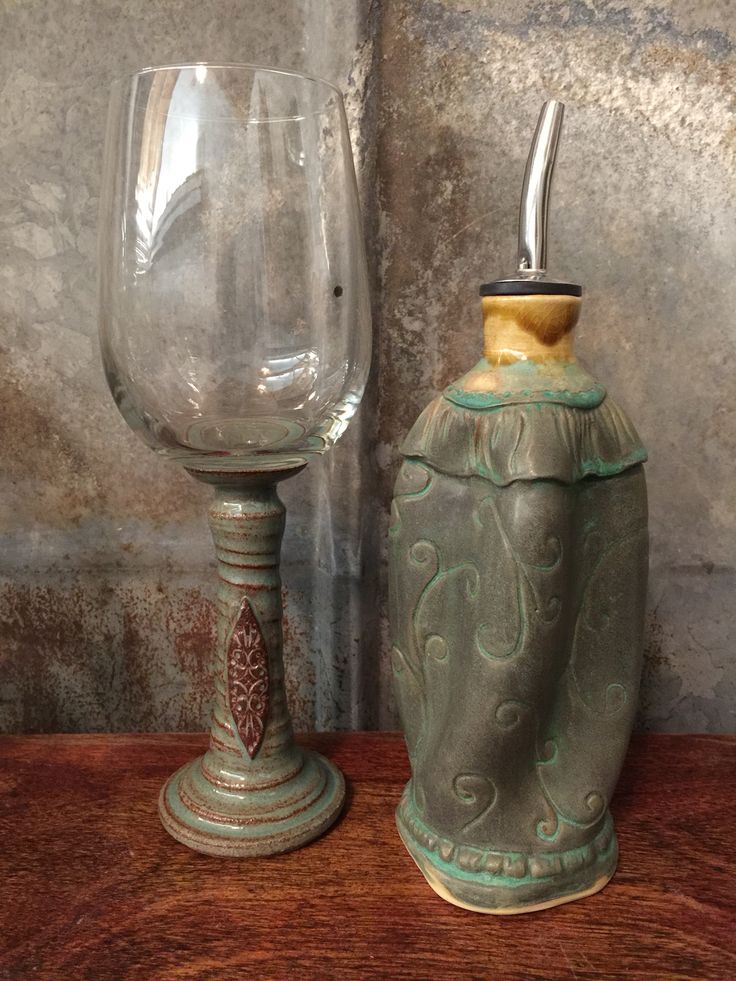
[227,599,268,759]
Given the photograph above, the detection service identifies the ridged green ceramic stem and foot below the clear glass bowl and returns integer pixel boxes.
[159,471,345,856]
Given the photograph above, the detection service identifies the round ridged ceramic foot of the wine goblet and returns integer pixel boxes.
[159,752,345,857]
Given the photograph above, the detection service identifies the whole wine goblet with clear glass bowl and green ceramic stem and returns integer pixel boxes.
[99,64,371,855]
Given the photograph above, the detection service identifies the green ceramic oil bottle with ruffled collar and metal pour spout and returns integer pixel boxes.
[390,102,648,913]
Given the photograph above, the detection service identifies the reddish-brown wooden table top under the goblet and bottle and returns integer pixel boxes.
[0,733,736,981]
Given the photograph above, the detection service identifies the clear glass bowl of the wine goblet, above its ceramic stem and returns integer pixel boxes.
[100,65,370,469]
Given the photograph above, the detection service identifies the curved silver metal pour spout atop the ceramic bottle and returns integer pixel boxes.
[518,99,565,279]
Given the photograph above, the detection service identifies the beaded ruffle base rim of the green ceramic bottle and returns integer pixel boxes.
[396,797,618,915]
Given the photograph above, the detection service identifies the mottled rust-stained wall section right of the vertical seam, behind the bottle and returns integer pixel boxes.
[378,0,736,731]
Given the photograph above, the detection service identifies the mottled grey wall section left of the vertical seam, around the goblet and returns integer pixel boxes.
[0,0,386,731]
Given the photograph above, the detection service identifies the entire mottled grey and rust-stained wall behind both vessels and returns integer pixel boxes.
[0,0,736,731]
